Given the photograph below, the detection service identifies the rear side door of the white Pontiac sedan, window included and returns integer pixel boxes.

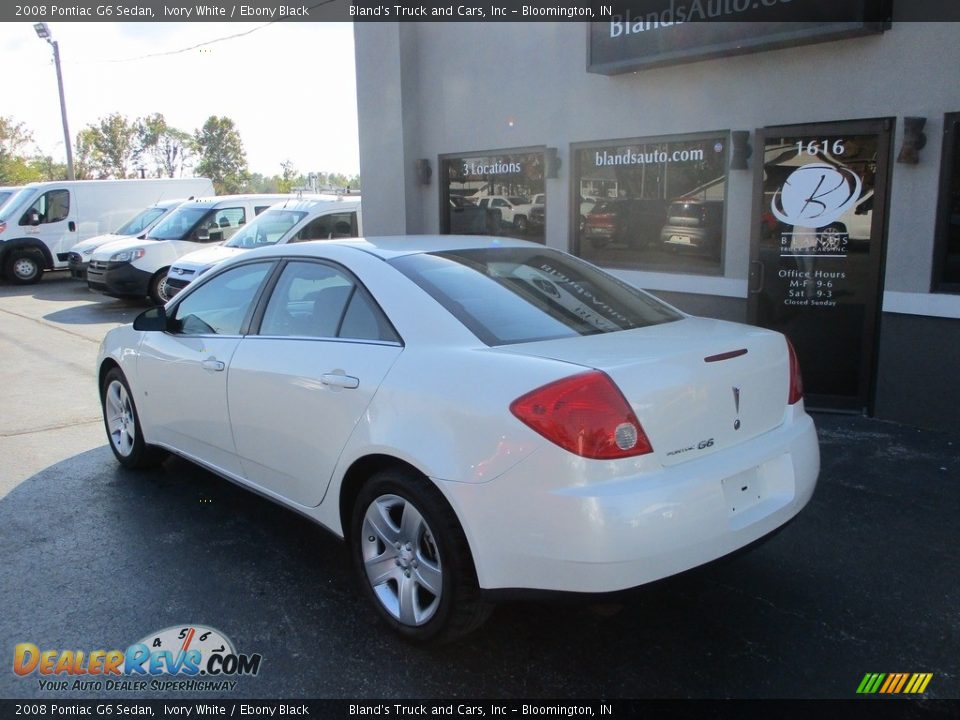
[227,260,402,507]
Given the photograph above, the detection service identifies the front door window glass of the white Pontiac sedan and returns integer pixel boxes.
[174,262,272,335]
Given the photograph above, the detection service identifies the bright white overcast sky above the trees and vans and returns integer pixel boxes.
[0,22,360,175]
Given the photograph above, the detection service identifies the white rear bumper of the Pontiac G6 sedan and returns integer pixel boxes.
[437,406,820,593]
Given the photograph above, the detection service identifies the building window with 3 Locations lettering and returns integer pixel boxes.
[440,150,546,243]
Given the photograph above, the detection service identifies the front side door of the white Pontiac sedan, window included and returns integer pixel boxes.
[137,261,274,475]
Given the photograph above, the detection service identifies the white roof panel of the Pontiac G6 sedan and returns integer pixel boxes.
[244,235,546,260]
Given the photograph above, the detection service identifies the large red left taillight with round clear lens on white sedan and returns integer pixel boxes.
[510,370,653,460]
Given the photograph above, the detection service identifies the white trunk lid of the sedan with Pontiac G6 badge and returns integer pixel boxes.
[497,318,790,465]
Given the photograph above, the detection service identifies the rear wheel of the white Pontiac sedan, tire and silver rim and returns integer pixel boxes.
[349,469,493,643]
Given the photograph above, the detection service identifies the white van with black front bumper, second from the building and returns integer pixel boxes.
[87,195,295,303]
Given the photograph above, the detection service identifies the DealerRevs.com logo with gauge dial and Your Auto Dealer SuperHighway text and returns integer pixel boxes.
[13,625,263,692]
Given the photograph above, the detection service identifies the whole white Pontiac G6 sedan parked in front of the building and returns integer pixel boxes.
[98,236,820,641]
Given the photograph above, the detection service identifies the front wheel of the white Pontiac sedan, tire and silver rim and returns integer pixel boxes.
[100,368,167,470]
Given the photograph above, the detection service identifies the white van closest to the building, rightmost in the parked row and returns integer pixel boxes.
[164,195,363,298]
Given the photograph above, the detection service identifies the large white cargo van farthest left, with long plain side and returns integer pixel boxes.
[0,178,213,285]
